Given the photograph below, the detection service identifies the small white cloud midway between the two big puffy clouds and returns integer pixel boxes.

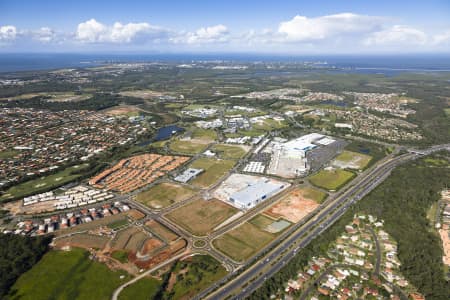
[171,24,229,44]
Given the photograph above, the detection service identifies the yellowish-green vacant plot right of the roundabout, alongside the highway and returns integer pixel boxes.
[213,222,275,261]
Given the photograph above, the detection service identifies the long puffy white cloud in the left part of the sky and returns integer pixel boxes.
[76,19,167,43]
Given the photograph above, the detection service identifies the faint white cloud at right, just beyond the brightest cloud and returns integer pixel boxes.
[364,25,428,47]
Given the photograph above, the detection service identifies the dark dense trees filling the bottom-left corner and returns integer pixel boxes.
[0,233,51,299]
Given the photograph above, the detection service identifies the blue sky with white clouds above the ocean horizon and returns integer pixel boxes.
[0,0,450,55]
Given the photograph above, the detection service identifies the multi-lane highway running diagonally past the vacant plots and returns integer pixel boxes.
[202,144,450,299]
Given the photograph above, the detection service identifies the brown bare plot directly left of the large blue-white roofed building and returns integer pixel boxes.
[166,199,238,236]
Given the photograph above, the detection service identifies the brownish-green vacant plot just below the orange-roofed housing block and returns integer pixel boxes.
[136,183,195,209]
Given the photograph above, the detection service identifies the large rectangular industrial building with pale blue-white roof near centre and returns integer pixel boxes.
[229,178,286,209]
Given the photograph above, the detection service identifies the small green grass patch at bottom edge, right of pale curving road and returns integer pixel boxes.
[119,277,162,300]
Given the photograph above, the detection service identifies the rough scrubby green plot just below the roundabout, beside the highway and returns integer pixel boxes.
[166,255,227,299]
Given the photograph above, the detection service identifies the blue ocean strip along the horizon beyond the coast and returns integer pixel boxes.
[0,53,450,75]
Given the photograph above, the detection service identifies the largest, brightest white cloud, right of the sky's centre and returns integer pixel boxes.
[278,13,384,42]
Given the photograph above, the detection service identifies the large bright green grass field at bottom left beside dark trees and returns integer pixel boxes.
[10,249,131,300]
